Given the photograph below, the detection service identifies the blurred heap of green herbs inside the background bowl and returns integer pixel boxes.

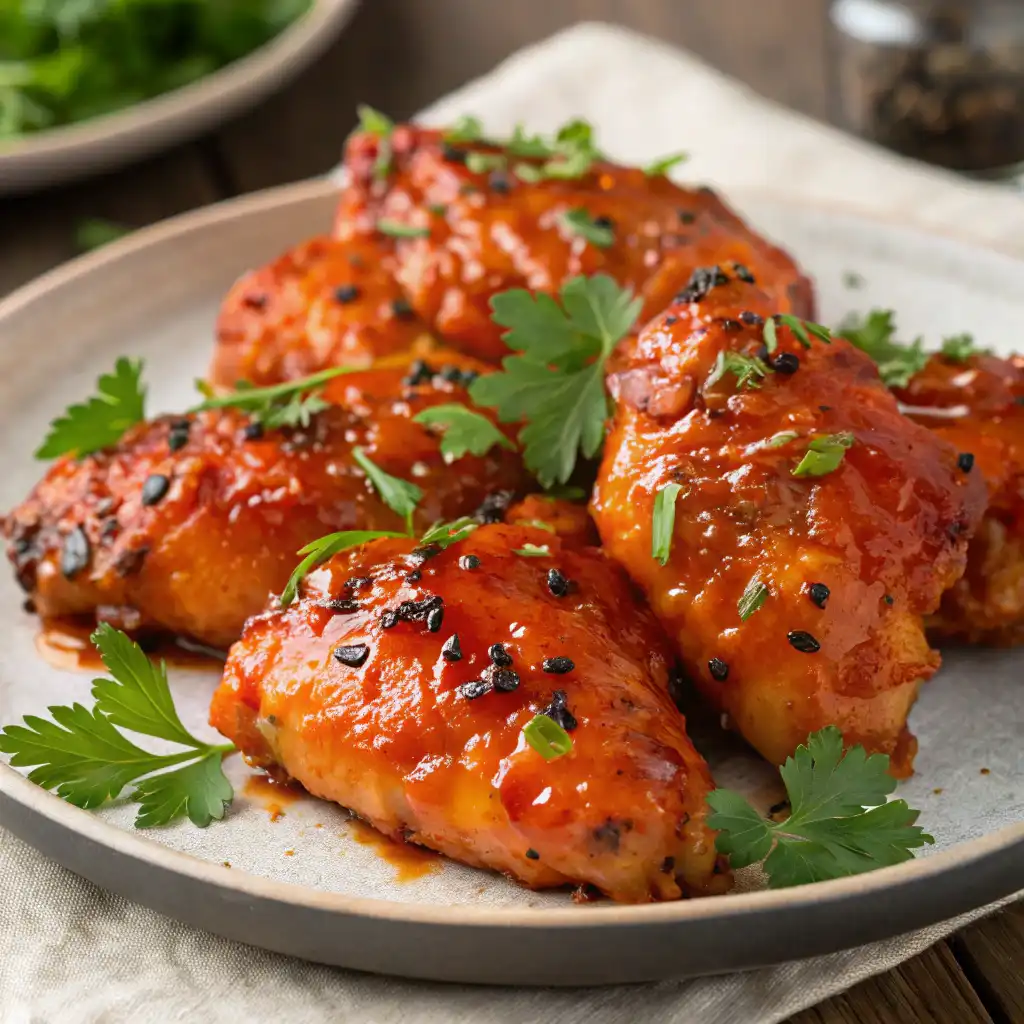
[0,0,311,142]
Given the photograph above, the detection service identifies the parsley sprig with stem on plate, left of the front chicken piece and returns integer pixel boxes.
[0,623,234,828]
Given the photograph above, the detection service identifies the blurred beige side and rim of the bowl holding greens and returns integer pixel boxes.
[0,0,357,196]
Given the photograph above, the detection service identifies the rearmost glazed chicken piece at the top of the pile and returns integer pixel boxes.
[335,125,813,360]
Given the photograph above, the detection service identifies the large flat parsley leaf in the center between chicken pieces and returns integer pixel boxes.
[469,273,643,486]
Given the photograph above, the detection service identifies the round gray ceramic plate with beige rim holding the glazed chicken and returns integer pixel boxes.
[0,182,1024,984]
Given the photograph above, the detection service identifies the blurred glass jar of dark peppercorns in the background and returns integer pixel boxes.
[830,0,1024,177]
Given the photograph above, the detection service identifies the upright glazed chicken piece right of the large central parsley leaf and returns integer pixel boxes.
[592,281,985,775]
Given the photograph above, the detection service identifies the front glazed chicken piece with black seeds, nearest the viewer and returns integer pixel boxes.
[210,524,727,902]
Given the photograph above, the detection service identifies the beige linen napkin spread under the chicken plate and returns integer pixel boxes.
[0,19,1024,1024]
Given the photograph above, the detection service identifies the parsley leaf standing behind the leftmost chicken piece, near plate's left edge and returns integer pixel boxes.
[36,356,145,459]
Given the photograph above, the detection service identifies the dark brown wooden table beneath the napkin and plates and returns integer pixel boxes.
[0,0,1024,1024]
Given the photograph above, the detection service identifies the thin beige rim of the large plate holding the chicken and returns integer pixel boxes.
[0,174,1024,930]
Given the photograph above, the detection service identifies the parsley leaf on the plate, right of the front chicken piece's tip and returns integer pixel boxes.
[708,726,934,889]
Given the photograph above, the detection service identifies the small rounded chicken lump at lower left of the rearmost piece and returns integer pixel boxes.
[210,237,426,387]
